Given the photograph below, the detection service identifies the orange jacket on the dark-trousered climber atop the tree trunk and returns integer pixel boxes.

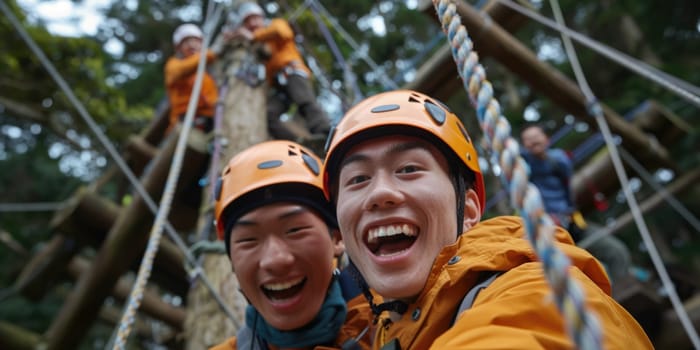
[253,18,311,82]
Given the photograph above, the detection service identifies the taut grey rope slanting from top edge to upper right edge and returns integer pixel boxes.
[497,0,700,107]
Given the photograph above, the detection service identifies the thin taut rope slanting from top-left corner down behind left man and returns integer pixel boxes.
[0,1,240,344]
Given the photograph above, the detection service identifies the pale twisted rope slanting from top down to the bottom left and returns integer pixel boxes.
[113,2,223,350]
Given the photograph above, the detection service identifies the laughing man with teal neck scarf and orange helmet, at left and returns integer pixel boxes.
[212,140,372,350]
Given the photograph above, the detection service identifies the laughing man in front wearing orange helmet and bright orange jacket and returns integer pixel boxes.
[323,90,652,349]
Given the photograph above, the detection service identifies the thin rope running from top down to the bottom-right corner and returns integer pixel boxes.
[549,0,700,349]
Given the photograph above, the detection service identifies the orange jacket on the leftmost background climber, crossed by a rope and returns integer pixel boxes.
[165,51,219,128]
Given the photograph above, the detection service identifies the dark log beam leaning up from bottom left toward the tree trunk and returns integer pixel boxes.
[47,130,197,349]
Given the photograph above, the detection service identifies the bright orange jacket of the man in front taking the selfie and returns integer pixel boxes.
[374,216,653,350]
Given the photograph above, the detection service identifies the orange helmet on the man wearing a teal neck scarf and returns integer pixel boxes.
[214,140,337,251]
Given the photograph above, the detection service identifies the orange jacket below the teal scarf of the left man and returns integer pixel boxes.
[210,295,374,350]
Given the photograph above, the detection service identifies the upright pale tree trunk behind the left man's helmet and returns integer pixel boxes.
[185,40,268,349]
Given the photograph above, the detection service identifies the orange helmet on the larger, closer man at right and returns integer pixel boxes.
[323,90,486,212]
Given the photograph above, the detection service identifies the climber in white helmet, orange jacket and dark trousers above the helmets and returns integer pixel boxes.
[228,2,330,144]
